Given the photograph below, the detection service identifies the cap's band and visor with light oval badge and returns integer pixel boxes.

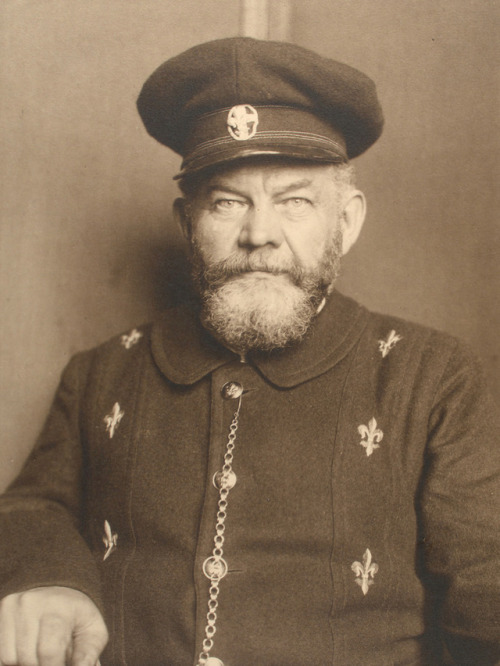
[182,104,347,174]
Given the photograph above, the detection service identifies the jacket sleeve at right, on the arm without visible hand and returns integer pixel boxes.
[421,345,500,666]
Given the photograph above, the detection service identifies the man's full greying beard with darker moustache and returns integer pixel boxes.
[193,233,342,353]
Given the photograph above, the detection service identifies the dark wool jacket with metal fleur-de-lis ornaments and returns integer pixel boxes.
[0,293,500,666]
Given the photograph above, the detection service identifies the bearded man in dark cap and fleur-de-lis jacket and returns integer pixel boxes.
[0,38,500,666]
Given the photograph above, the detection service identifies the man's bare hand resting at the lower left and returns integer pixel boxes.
[0,587,108,666]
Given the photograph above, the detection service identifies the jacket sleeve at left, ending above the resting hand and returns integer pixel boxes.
[0,354,102,607]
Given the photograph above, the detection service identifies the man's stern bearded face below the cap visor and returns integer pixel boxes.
[180,161,356,351]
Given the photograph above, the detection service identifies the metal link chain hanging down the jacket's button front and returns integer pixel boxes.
[197,396,241,666]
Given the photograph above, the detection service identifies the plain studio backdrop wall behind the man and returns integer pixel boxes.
[0,0,500,487]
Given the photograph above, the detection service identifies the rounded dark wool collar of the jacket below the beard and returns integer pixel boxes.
[151,291,368,388]
